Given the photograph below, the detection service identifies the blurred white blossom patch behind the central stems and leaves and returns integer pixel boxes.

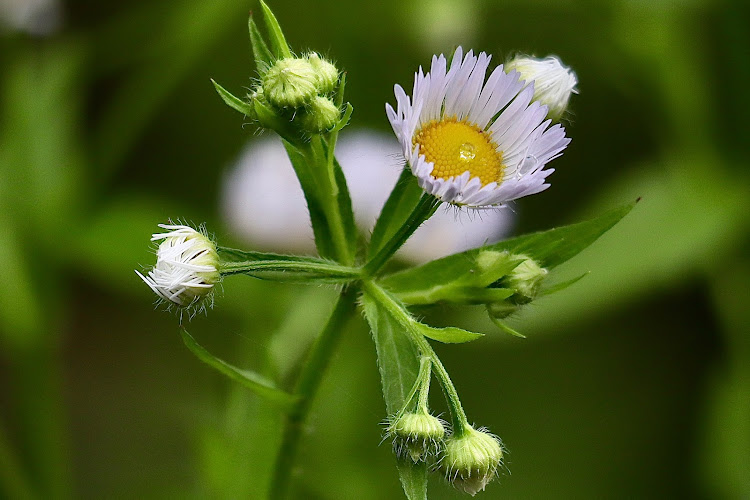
[221,131,514,262]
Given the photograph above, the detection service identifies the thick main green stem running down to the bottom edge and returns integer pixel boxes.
[269,286,357,499]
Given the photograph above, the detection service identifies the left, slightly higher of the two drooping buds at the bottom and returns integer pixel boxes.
[387,411,445,463]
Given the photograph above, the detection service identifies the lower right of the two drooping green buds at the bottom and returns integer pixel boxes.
[440,425,503,496]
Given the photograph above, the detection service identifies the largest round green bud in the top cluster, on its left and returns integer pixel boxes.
[262,57,318,108]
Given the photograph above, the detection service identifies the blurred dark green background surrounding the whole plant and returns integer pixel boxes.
[0,0,750,499]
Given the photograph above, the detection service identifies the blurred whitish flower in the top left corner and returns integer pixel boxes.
[0,0,61,36]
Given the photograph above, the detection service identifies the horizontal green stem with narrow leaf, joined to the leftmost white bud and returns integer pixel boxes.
[217,247,360,283]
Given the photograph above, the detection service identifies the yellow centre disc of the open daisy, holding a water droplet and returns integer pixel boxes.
[413,118,505,186]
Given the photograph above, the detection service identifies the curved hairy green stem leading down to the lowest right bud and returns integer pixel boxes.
[364,280,469,436]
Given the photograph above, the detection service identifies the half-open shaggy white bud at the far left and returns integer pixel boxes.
[136,224,220,307]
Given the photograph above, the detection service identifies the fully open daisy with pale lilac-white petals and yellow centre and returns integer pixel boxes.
[386,47,570,207]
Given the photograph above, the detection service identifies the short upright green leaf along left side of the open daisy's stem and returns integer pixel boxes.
[367,168,424,258]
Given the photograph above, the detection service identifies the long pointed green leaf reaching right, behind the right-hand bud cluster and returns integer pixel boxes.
[382,202,636,303]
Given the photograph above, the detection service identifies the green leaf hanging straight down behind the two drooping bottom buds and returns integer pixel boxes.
[362,294,427,500]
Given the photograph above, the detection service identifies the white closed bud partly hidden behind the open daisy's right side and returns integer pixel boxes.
[505,56,578,120]
